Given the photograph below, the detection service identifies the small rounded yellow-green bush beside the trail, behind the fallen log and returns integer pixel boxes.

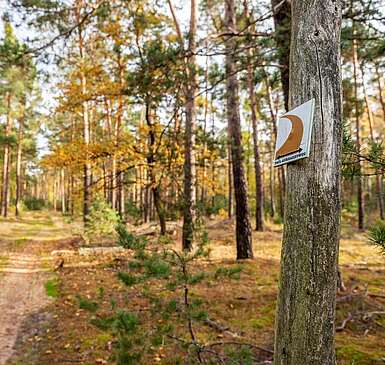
[84,195,120,241]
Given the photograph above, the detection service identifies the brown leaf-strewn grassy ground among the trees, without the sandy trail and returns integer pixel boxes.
[4,212,385,365]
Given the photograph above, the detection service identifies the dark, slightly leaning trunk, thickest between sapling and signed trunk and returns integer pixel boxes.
[225,0,253,259]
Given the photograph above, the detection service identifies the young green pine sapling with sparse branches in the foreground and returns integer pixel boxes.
[86,222,250,365]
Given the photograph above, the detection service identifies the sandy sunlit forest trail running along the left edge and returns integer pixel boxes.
[0,212,76,365]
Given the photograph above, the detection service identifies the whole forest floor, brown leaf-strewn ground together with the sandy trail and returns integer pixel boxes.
[0,211,385,365]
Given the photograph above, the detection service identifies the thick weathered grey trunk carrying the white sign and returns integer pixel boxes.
[274,0,342,365]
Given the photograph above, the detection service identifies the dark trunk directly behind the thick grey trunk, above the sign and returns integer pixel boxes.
[271,0,292,111]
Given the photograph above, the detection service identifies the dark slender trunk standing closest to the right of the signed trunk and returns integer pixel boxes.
[352,21,365,230]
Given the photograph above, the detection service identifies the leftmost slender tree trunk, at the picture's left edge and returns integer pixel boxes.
[1,93,12,217]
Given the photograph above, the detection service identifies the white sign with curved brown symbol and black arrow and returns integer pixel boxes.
[274,99,315,166]
